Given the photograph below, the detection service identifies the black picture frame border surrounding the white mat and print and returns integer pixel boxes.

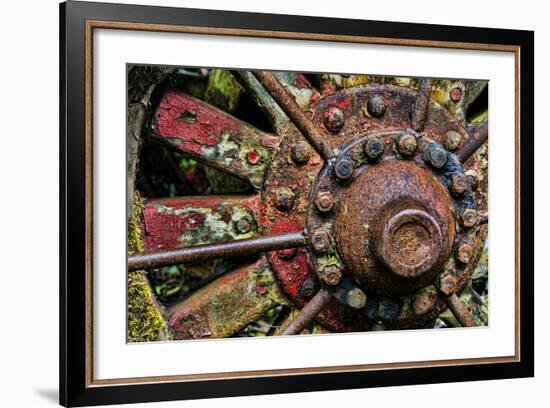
[60,1,534,406]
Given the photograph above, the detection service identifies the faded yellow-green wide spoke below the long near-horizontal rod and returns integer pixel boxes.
[168,257,286,339]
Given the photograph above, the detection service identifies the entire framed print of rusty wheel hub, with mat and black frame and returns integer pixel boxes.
[60,1,534,406]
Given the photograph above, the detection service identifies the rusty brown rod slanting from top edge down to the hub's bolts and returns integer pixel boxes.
[254,71,334,160]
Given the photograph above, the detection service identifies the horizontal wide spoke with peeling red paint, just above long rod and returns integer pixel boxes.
[141,195,259,252]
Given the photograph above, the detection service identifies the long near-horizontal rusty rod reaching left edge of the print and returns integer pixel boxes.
[128,232,306,271]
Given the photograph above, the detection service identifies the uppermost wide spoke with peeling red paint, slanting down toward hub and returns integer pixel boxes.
[155,90,279,188]
